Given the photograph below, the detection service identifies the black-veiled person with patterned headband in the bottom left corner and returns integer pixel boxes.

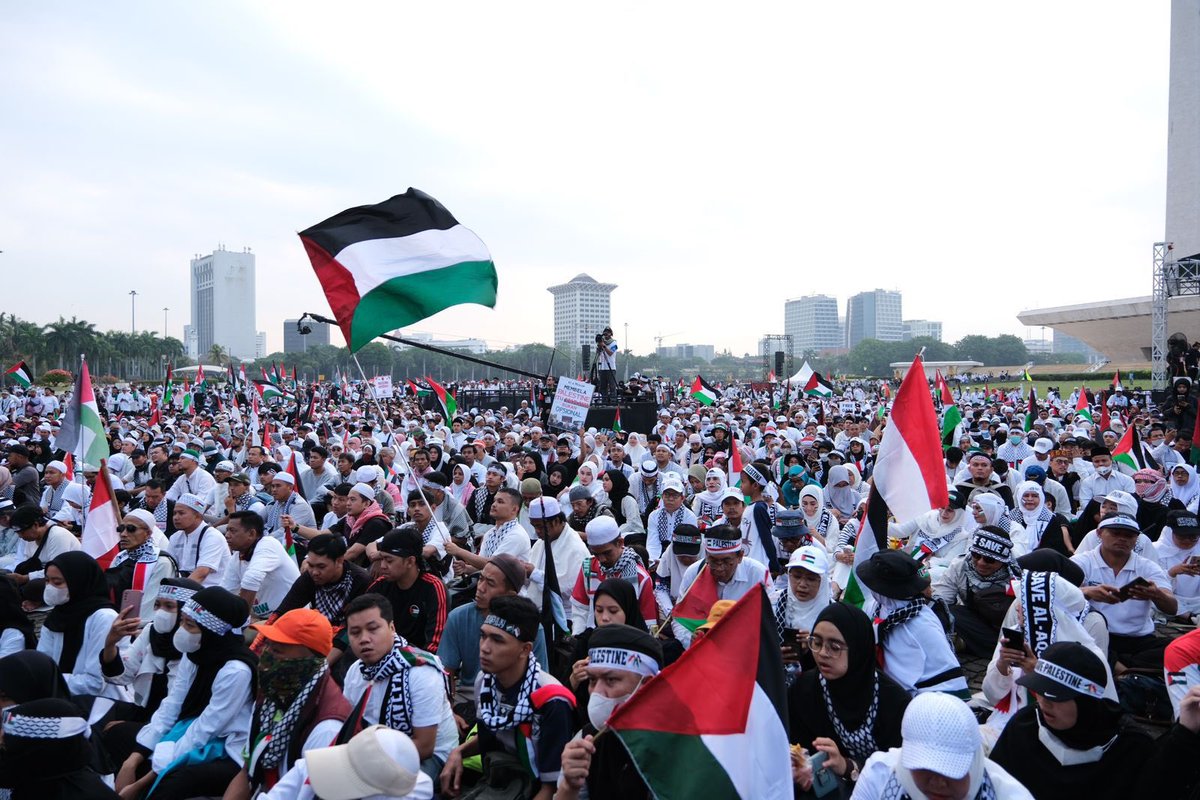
[0,698,119,800]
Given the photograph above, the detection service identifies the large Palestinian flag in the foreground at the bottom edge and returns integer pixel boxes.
[607,587,793,800]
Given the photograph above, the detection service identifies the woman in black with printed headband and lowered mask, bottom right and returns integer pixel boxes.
[991,642,1194,800]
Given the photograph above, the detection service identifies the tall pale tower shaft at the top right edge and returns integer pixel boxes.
[1164,0,1200,258]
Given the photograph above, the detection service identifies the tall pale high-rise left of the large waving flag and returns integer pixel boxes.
[191,245,258,360]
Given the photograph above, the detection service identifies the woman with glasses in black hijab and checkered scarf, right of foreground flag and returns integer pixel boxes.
[787,603,908,794]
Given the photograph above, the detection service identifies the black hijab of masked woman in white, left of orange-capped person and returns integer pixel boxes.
[179,587,258,720]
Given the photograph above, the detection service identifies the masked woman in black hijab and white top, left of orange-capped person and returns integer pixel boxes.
[116,587,258,800]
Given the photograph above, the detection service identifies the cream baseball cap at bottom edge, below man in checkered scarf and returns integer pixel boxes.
[305,724,421,800]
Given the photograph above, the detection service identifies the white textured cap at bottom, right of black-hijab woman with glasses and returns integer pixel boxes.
[900,692,983,781]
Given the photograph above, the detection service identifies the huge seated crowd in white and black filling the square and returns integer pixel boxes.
[0,371,1200,800]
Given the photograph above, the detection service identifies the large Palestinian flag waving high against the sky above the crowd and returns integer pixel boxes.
[300,188,498,351]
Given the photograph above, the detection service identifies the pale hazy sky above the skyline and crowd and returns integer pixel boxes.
[0,0,1170,354]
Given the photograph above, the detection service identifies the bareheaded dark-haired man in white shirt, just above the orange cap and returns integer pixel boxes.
[221,511,300,619]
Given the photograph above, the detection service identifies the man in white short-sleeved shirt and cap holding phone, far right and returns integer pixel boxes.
[1072,515,1178,669]
